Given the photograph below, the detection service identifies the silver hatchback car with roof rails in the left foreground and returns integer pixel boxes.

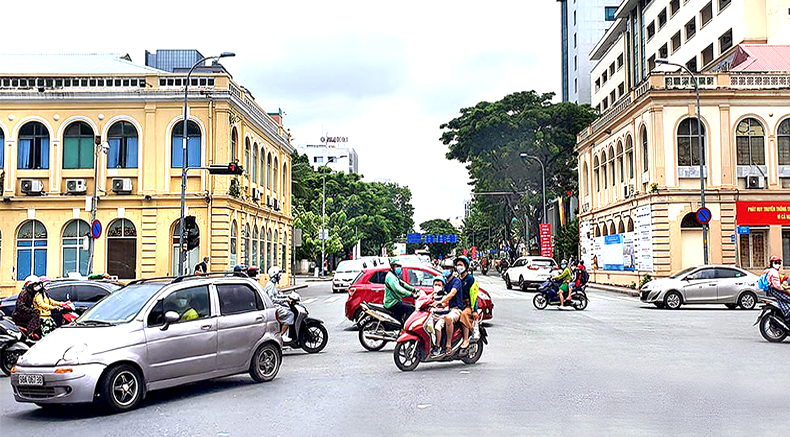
[11,276,282,412]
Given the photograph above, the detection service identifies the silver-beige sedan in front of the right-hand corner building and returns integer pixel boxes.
[640,265,765,309]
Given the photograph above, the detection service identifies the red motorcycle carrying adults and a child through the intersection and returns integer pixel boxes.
[394,299,488,372]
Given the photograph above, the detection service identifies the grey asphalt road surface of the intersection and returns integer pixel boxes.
[0,276,790,437]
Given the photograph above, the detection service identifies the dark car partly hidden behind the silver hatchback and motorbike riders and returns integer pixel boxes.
[0,279,123,322]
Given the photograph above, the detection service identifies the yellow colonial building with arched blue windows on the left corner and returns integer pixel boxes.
[0,54,294,295]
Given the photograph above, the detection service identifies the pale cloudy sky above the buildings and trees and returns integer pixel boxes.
[3,0,561,225]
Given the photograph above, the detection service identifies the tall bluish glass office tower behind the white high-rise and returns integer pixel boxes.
[558,0,619,103]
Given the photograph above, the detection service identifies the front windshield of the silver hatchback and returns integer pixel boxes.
[77,282,165,325]
